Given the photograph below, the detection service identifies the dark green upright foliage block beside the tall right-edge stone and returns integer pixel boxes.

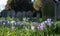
[43,2,54,18]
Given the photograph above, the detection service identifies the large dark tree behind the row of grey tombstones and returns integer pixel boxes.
[6,0,33,11]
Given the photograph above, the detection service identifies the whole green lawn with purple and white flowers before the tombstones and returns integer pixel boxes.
[0,17,60,36]
